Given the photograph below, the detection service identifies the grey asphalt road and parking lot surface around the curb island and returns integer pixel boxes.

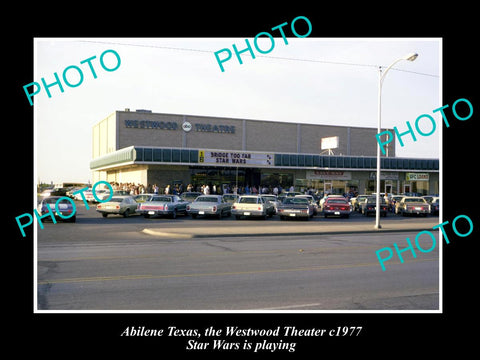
[36,201,439,311]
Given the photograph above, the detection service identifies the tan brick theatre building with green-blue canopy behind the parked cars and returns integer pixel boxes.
[90,109,439,194]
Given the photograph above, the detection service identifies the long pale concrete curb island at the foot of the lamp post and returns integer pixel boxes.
[142,218,438,239]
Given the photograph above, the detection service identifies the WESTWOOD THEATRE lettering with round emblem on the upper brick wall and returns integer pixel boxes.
[125,120,235,134]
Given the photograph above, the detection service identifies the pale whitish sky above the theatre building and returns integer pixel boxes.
[32,37,443,183]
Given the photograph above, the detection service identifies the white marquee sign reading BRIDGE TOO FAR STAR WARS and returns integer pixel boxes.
[198,150,273,166]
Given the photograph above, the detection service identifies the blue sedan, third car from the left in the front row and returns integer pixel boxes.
[136,195,189,219]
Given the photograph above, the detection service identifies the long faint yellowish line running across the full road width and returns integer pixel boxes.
[37,258,438,285]
